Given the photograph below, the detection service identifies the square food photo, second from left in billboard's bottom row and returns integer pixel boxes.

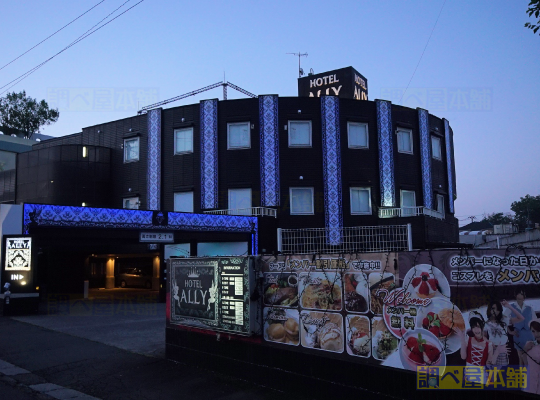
[300,311,344,353]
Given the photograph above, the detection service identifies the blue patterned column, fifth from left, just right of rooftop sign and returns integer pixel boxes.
[375,100,396,207]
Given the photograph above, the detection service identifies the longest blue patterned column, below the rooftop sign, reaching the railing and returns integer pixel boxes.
[321,96,343,246]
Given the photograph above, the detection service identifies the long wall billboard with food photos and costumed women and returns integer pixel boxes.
[261,249,540,394]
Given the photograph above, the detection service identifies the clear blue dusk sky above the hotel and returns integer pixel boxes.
[0,0,540,225]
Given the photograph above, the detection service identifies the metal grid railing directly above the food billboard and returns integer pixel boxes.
[277,224,412,254]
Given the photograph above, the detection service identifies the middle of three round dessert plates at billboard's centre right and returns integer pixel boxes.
[416,297,465,354]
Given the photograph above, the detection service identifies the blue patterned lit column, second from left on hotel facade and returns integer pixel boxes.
[201,99,218,210]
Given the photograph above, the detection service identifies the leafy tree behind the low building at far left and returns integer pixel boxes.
[0,90,60,138]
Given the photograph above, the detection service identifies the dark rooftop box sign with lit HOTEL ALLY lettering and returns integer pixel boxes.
[298,67,368,100]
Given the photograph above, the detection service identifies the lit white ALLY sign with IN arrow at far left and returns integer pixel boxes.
[2,236,33,293]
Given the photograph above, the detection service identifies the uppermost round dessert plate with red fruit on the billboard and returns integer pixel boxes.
[403,264,450,299]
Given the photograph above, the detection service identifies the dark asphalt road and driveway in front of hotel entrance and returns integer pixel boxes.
[0,289,298,400]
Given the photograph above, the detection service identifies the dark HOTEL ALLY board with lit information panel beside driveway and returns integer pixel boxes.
[167,257,251,334]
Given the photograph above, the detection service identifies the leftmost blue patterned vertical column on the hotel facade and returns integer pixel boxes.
[146,108,161,210]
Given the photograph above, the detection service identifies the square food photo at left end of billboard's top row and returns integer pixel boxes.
[263,273,298,307]
